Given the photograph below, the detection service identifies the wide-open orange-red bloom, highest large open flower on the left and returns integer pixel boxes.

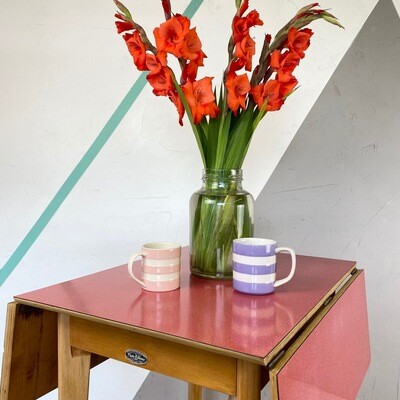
[153,14,190,58]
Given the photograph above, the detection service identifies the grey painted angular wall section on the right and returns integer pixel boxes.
[256,0,400,400]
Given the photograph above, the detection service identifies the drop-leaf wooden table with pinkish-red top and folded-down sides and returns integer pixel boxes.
[0,249,370,400]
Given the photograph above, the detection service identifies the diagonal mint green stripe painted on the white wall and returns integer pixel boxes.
[0,0,204,286]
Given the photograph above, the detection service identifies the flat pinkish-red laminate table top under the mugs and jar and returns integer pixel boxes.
[15,248,355,362]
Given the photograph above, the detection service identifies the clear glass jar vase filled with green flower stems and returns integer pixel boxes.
[189,169,254,279]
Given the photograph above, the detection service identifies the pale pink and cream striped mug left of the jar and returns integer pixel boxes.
[128,242,181,292]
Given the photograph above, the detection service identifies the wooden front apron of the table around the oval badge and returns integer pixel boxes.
[70,316,238,395]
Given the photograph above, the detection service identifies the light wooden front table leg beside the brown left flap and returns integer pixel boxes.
[58,314,90,400]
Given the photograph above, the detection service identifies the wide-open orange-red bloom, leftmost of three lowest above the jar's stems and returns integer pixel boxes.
[182,77,219,124]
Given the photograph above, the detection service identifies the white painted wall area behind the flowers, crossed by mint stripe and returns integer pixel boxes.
[0,0,376,400]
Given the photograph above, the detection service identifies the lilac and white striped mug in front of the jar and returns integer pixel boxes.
[232,238,296,294]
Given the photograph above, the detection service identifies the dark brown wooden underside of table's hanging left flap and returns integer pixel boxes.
[0,302,57,400]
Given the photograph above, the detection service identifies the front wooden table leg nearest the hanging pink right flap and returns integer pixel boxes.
[236,360,261,400]
